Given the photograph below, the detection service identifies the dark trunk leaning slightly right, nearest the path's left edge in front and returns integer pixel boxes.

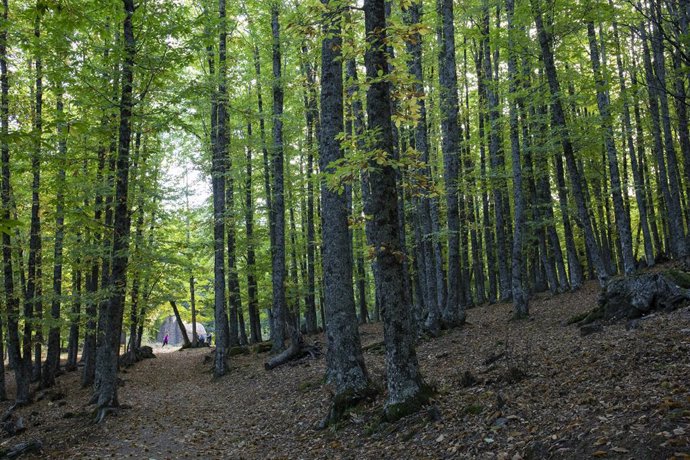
[96,0,136,421]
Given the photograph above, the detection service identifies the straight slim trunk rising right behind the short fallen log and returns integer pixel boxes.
[271,2,286,353]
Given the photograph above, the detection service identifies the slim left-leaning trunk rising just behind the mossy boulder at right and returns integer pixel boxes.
[587,21,635,275]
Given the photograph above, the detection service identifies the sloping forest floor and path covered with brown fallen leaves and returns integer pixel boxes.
[0,274,690,460]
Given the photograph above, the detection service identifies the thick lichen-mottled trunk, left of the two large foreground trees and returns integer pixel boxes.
[319,0,369,423]
